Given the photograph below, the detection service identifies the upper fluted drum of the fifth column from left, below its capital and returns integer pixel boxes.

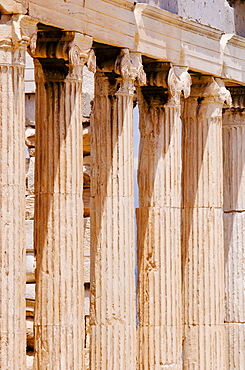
[183,104,223,207]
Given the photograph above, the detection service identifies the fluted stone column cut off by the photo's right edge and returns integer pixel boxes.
[223,88,245,370]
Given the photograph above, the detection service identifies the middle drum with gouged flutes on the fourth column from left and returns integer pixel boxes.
[137,207,181,320]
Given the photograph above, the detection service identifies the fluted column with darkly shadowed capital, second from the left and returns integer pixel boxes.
[31,32,94,370]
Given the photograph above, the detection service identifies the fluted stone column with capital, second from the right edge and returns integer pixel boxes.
[182,77,230,370]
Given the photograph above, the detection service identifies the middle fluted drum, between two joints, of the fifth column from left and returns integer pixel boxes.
[182,208,224,326]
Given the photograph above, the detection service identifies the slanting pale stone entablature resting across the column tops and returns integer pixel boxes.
[23,0,245,83]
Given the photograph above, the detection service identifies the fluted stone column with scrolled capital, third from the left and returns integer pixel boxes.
[91,49,144,370]
